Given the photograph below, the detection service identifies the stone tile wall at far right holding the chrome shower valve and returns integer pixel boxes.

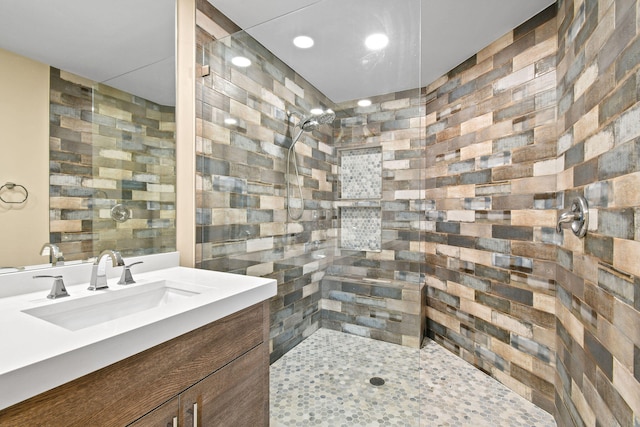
[555,0,640,426]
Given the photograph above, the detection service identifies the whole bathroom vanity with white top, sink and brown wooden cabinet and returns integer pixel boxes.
[0,253,276,427]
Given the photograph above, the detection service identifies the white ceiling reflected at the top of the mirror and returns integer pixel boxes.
[0,0,175,105]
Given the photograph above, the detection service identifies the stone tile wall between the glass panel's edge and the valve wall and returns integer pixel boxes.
[424,5,561,412]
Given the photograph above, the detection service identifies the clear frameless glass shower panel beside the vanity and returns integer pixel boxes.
[196,0,424,425]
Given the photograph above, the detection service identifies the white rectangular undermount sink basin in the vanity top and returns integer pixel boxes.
[22,280,211,331]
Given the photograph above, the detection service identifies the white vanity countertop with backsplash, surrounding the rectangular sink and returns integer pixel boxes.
[0,255,277,409]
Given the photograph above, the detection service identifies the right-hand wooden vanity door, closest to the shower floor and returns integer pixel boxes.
[180,344,269,427]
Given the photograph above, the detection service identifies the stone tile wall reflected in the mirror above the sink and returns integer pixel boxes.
[49,68,176,261]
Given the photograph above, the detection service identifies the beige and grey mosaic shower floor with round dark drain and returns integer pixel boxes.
[270,329,556,427]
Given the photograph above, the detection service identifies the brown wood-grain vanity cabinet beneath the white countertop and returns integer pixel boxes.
[0,301,269,427]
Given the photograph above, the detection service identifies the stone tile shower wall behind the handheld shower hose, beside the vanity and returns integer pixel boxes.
[196,5,336,360]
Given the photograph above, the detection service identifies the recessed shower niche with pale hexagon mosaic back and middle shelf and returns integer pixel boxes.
[338,146,382,252]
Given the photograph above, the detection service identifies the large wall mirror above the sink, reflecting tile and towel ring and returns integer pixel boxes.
[0,0,176,273]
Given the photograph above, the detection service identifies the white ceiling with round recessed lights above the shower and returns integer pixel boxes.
[208,0,555,102]
